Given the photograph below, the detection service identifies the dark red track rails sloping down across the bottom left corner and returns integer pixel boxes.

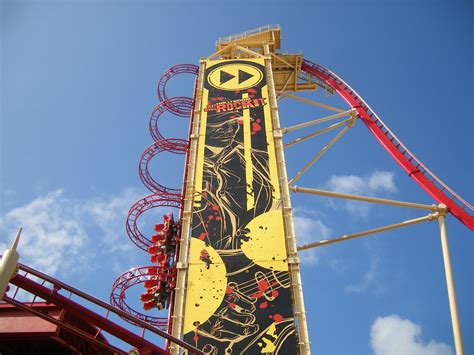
[3,264,202,354]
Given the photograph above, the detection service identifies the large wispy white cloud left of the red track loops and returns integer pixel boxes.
[0,189,143,277]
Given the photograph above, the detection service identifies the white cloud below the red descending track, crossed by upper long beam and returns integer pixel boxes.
[323,171,397,218]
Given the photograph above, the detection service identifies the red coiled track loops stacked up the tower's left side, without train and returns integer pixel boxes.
[110,64,199,340]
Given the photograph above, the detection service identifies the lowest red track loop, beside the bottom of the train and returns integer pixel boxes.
[110,266,168,331]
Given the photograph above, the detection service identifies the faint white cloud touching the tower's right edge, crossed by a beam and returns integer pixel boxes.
[293,209,331,265]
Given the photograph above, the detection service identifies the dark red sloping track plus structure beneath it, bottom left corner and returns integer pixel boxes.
[0,264,200,354]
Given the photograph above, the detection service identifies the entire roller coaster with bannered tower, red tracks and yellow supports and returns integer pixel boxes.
[4,25,474,354]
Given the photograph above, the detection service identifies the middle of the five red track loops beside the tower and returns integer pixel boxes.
[138,138,188,194]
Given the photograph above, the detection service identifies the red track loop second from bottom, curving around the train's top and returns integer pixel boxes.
[125,191,182,252]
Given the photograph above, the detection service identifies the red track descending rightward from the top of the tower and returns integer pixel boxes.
[301,59,474,230]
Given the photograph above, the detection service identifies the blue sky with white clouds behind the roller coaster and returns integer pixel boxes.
[0,0,474,355]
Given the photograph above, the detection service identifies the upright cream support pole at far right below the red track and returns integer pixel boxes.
[438,211,464,355]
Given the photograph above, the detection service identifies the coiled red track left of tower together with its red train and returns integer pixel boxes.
[110,64,198,340]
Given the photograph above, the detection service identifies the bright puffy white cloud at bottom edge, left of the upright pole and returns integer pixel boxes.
[370,315,454,355]
